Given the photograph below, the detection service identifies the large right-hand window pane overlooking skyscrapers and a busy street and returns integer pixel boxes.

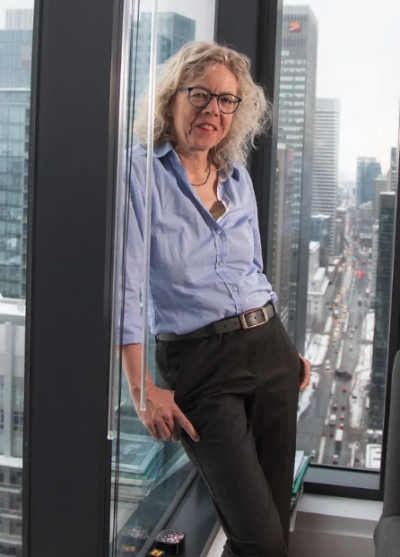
[272,0,400,470]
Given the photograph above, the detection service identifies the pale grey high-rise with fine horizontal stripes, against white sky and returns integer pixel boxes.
[312,99,340,255]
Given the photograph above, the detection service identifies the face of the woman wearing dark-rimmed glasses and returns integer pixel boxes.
[172,64,238,153]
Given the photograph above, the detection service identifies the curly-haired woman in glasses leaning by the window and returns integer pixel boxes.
[122,43,310,557]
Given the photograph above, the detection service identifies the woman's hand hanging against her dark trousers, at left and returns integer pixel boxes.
[131,384,200,443]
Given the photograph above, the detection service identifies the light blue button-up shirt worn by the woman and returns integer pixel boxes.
[123,143,277,344]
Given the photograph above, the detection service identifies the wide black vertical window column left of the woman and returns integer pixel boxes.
[22,0,123,557]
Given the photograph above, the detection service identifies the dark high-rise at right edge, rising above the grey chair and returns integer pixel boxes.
[369,192,396,429]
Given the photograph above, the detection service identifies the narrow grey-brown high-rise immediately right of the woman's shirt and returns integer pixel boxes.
[272,143,294,328]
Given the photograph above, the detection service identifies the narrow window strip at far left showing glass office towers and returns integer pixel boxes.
[0,5,33,555]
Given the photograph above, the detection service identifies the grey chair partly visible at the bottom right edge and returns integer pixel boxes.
[374,351,400,557]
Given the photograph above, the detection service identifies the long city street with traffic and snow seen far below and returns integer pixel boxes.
[297,219,372,467]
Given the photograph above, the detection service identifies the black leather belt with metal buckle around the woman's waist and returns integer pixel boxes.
[156,301,275,340]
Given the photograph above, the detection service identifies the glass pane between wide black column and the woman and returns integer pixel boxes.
[111,0,215,550]
